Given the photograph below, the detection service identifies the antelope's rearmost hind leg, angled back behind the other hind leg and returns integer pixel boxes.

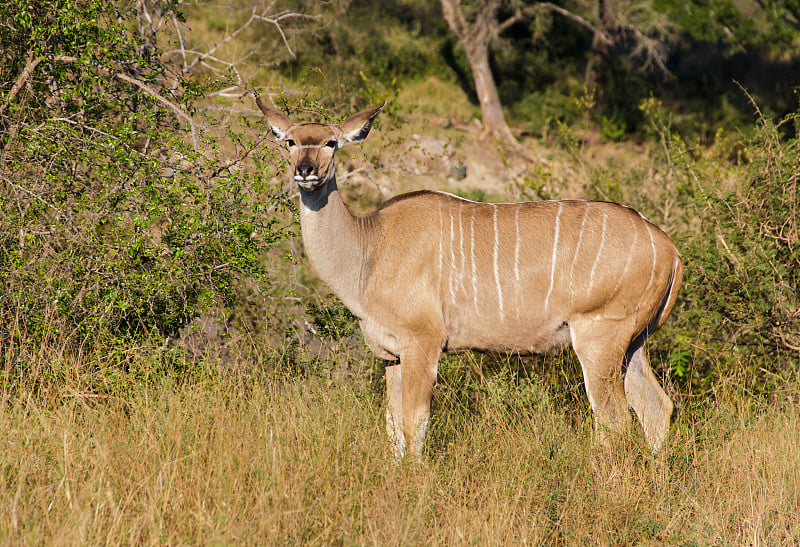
[624,345,673,452]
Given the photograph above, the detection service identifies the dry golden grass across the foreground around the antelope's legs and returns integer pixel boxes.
[0,346,800,545]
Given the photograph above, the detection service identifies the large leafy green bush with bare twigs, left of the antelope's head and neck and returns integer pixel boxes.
[0,0,289,352]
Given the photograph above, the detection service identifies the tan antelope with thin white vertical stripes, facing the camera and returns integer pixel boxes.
[256,98,683,460]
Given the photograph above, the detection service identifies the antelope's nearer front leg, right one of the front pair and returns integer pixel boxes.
[400,338,441,461]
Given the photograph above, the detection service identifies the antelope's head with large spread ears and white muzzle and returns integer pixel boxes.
[256,98,386,192]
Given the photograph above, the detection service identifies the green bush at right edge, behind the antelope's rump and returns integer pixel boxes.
[644,98,800,390]
